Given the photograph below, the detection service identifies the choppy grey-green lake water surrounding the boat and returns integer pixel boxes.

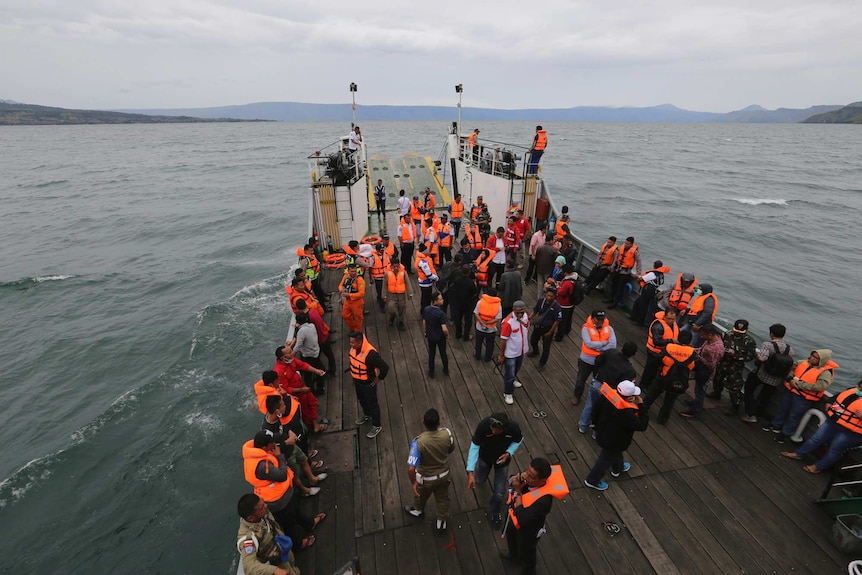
[0,122,862,573]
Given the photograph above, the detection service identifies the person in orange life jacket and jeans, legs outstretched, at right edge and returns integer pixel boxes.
[781,380,862,473]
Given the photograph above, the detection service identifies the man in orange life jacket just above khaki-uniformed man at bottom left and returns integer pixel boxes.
[242,429,326,548]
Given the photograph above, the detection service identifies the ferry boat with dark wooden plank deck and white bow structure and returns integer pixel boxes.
[248,100,862,575]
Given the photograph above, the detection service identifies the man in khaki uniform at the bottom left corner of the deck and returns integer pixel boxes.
[236,493,299,575]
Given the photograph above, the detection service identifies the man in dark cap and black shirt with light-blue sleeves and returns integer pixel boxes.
[467,413,524,527]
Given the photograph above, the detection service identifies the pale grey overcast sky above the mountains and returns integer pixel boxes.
[0,0,862,112]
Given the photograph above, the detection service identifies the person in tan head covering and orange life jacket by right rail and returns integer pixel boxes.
[764,349,839,443]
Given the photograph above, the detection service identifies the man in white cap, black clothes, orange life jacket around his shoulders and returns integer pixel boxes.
[584,380,649,491]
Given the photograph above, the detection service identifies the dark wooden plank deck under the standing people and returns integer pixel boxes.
[298,230,851,575]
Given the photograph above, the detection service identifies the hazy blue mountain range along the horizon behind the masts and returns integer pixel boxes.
[122,102,841,123]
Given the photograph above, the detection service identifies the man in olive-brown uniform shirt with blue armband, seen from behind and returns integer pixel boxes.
[404,409,455,533]
